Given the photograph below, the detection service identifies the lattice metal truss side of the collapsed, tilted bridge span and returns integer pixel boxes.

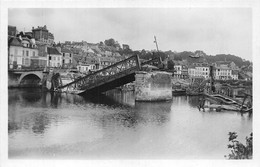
[57,55,141,90]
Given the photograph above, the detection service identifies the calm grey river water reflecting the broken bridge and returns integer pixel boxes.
[8,89,252,159]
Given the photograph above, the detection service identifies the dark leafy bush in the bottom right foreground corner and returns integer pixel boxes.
[225,132,253,159]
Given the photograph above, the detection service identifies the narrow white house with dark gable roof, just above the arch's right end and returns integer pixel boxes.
[47,47,62,67]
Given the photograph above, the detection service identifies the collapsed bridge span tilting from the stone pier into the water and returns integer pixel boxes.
[56,55,144,94]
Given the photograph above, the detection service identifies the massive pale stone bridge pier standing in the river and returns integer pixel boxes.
[135,72,172,101]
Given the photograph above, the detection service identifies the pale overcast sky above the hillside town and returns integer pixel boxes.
[8,8,252,60]
